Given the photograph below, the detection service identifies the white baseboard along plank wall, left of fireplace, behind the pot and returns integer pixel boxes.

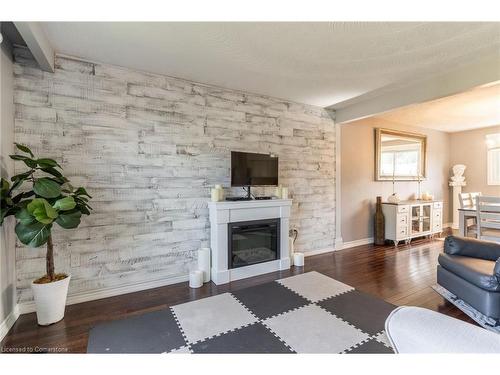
[18,275,189,314]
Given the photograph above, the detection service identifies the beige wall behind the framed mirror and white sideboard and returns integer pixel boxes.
[341,118,450,242]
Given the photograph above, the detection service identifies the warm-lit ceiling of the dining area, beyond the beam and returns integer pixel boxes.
[374,83,500,132]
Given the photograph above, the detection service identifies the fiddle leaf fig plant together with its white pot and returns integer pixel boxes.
[0,143,92,325]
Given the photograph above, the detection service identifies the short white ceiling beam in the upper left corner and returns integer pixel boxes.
[14,22,54,73]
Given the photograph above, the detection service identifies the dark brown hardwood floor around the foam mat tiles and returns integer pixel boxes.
[0,239,473,353]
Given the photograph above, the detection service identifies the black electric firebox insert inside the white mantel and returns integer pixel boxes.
[228,219,280,268]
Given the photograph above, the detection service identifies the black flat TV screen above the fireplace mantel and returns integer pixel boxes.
[231,151,278,186]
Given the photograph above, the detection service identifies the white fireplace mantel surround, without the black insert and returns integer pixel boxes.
[208,199,292,285]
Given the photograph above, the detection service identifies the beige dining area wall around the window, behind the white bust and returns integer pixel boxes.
[450,126,500,195]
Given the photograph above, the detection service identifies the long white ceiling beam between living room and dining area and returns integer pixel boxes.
[330,53,500,123]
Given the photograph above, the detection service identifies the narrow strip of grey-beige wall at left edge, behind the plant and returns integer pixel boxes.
[0,44,16,339]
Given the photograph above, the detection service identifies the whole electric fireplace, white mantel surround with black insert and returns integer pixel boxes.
[208,199,292,285]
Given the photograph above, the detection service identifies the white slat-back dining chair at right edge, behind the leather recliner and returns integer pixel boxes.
[476,196,500,243]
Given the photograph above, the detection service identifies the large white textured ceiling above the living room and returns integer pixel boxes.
[43,22,500,106]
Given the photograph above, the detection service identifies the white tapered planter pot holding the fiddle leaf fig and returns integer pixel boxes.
[31,275,71,326]
